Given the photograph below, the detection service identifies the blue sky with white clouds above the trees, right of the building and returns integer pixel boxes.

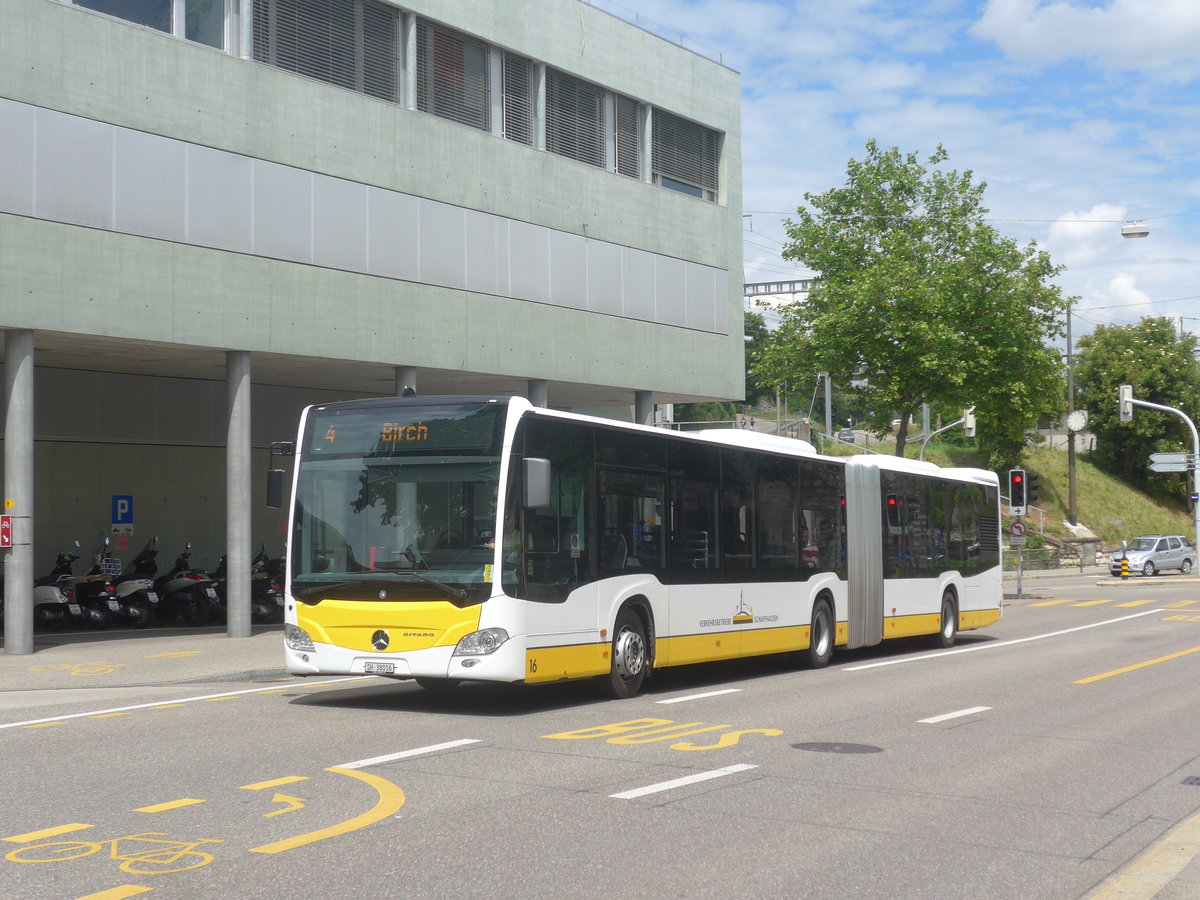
[609,0,1200,338]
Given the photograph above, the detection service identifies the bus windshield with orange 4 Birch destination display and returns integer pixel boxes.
[292,400,506,604]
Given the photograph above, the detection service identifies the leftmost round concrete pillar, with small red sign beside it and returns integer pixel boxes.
[0,329,34,655]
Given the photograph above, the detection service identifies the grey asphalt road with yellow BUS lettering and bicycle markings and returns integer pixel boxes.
[0,575,1200,900]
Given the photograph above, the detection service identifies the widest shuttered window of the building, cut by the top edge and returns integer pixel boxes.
[254,0,400,102]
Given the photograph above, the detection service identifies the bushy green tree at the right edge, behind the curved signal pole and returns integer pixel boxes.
[1075,317,1200,497]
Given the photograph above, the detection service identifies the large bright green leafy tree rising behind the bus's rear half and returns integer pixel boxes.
[757,140,1070,468]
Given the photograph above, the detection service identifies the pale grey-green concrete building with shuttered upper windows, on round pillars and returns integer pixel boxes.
[0,0,743,652]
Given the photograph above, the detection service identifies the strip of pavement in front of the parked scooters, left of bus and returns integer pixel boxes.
[0,625,289,691]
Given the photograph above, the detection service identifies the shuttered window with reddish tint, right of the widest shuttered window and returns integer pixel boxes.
[416,20,491,131]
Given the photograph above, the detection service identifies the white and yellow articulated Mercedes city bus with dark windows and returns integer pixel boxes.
[284,397,1001,697]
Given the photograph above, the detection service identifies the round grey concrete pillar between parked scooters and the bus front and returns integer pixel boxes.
[226,350,254,637]
